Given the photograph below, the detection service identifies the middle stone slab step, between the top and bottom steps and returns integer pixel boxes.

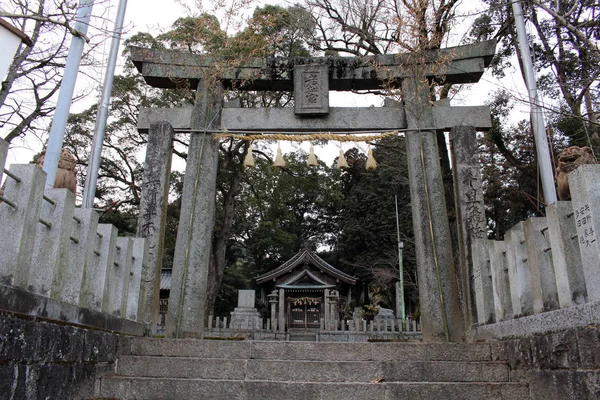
[117,356,509,382]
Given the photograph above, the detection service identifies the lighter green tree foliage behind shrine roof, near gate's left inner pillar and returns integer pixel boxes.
[210,150,341,312]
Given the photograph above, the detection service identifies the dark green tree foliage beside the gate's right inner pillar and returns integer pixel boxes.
[335,138,417,308]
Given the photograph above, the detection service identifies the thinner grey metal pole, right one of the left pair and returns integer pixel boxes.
[83,0,127,208]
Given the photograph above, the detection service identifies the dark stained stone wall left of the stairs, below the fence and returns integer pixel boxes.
[0,312,131,399]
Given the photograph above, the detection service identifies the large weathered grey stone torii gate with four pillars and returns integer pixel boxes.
[130,41,496,341]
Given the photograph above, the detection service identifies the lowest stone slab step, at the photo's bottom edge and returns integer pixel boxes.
[100,377,530,400]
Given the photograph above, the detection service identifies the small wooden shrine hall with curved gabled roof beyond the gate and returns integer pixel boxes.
[256,248,356,330]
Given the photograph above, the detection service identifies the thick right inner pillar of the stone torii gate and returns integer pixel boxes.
[402,74,463,341]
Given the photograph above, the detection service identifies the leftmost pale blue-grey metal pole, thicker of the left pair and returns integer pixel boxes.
[43,0,94,188]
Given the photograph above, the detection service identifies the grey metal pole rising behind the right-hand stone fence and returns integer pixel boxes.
[512,0,557,204]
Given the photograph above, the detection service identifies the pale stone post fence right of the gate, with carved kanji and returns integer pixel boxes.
[472,165,600,339]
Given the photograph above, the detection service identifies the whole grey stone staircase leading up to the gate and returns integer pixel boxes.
[97,338,530,400]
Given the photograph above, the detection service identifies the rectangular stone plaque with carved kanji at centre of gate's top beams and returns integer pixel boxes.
[294,65,329,115]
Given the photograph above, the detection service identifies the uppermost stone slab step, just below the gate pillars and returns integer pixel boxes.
[132,338,491,361]
